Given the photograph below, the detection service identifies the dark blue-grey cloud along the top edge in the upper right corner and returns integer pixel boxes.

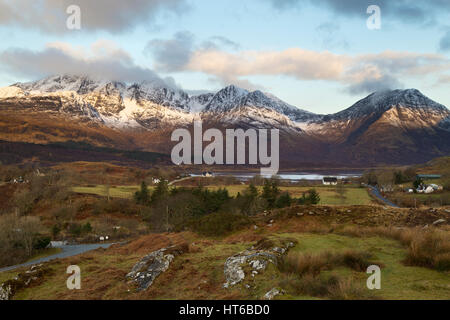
[266,0,450,24]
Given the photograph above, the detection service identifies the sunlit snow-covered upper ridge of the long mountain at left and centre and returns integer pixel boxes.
[0,75,317,129]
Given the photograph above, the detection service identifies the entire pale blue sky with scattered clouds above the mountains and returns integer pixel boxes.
[0,0,450,114]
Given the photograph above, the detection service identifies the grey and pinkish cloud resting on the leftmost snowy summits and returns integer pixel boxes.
[0,40,169,85]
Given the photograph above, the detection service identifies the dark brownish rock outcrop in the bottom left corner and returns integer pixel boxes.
[0,264,49,300]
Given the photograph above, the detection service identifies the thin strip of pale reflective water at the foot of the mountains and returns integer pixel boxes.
[191,171,362,182]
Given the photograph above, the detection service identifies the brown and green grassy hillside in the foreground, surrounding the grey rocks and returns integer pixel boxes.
[0,206,450,300]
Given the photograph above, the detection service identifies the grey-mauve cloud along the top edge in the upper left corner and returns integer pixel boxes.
[0,0,189,33]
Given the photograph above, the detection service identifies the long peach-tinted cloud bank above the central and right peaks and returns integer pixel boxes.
[148,34,450,94]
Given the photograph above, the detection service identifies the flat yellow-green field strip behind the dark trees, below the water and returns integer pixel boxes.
[72,185,372,205]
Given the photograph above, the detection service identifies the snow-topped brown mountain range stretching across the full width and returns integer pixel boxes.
[0,75,450,165]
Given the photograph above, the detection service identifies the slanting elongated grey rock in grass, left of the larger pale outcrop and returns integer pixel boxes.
[126,244,188,292]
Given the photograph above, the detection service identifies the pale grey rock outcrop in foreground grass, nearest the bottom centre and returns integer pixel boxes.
[223,240,295,288]
